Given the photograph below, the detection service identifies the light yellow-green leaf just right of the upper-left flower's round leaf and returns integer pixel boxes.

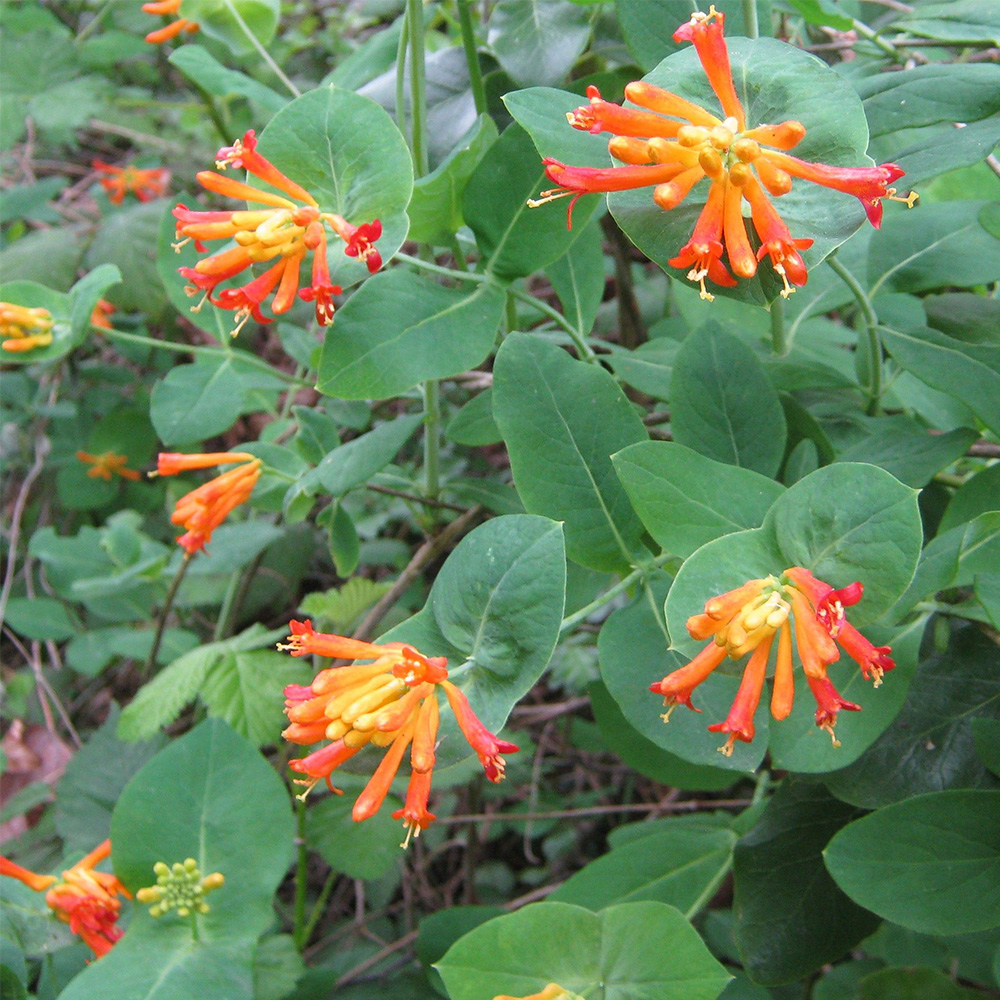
[407,115,498,244]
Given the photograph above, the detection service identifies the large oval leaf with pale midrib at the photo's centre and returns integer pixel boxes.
[493,333,647,570]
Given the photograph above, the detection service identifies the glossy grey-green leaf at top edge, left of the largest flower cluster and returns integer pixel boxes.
[487,0,590,87]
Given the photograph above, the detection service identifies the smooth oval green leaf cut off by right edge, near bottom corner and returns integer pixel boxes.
[824,789,1000,934]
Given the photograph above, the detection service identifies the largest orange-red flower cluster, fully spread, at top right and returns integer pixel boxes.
[528,7,916,301]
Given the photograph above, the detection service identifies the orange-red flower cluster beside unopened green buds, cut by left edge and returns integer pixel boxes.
[0,840,130,958]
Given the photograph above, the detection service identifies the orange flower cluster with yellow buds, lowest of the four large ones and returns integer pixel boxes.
[278,621,518,846]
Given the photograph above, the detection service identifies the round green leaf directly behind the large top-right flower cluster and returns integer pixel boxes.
[594,38,873,304]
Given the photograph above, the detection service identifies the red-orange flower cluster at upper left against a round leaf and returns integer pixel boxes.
[174,129,382,336]
